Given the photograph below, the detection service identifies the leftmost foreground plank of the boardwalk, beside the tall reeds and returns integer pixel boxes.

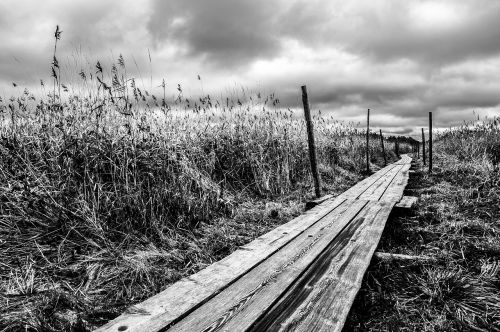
[96,198,345,332]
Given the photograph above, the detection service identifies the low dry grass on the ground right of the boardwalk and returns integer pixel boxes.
[345,119,500,331]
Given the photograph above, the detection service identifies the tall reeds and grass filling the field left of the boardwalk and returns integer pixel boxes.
[0,28,410,331]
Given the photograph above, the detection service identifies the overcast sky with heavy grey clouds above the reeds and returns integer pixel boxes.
[0,0,500,133]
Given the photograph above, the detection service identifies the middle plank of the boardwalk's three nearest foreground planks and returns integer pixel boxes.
[158,200,366,332]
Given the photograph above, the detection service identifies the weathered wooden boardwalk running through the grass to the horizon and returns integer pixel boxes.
[97,155,411,332]
